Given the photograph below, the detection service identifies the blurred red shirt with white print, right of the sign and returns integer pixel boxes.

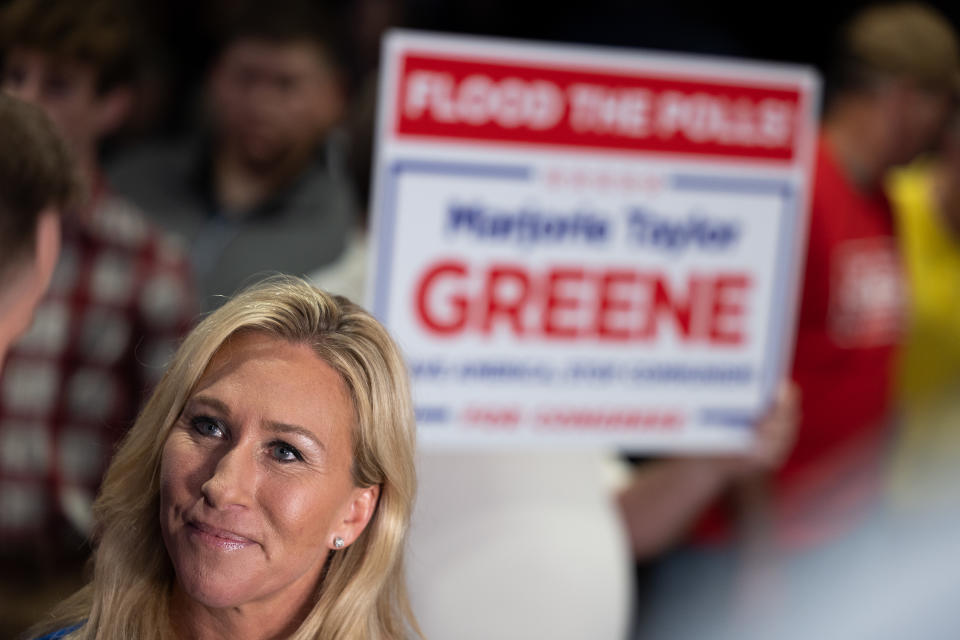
[695,137,905,549]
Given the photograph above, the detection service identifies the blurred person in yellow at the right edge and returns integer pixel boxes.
[888,105,960,518]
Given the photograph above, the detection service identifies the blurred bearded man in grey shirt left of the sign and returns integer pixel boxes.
[111,0,355,308]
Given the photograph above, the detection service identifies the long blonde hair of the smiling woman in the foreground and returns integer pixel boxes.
[35,277,420,640]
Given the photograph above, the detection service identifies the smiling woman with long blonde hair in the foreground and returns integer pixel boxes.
[36,278,419,640]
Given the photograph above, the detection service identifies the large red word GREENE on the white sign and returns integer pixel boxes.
[415,260,751,347]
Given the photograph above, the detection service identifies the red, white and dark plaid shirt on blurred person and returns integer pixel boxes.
[0,182,197,557]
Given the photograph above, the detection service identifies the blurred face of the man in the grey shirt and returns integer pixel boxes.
[211,40,341,166]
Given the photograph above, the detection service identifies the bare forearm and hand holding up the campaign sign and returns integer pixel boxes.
[618,384,799,560]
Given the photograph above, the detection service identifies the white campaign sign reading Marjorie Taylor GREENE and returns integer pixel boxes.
[369,32,819,451]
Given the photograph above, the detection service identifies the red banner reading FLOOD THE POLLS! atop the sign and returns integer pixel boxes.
[393,54,803,161]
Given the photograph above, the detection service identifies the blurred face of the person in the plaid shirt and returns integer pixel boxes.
[3,48,105,156]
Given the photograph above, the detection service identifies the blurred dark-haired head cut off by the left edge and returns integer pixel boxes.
[0,93,76,367]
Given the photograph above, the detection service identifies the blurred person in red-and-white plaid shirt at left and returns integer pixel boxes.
[0,0,196,635]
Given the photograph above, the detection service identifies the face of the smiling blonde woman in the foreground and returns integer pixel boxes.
[160,333,378,610]
